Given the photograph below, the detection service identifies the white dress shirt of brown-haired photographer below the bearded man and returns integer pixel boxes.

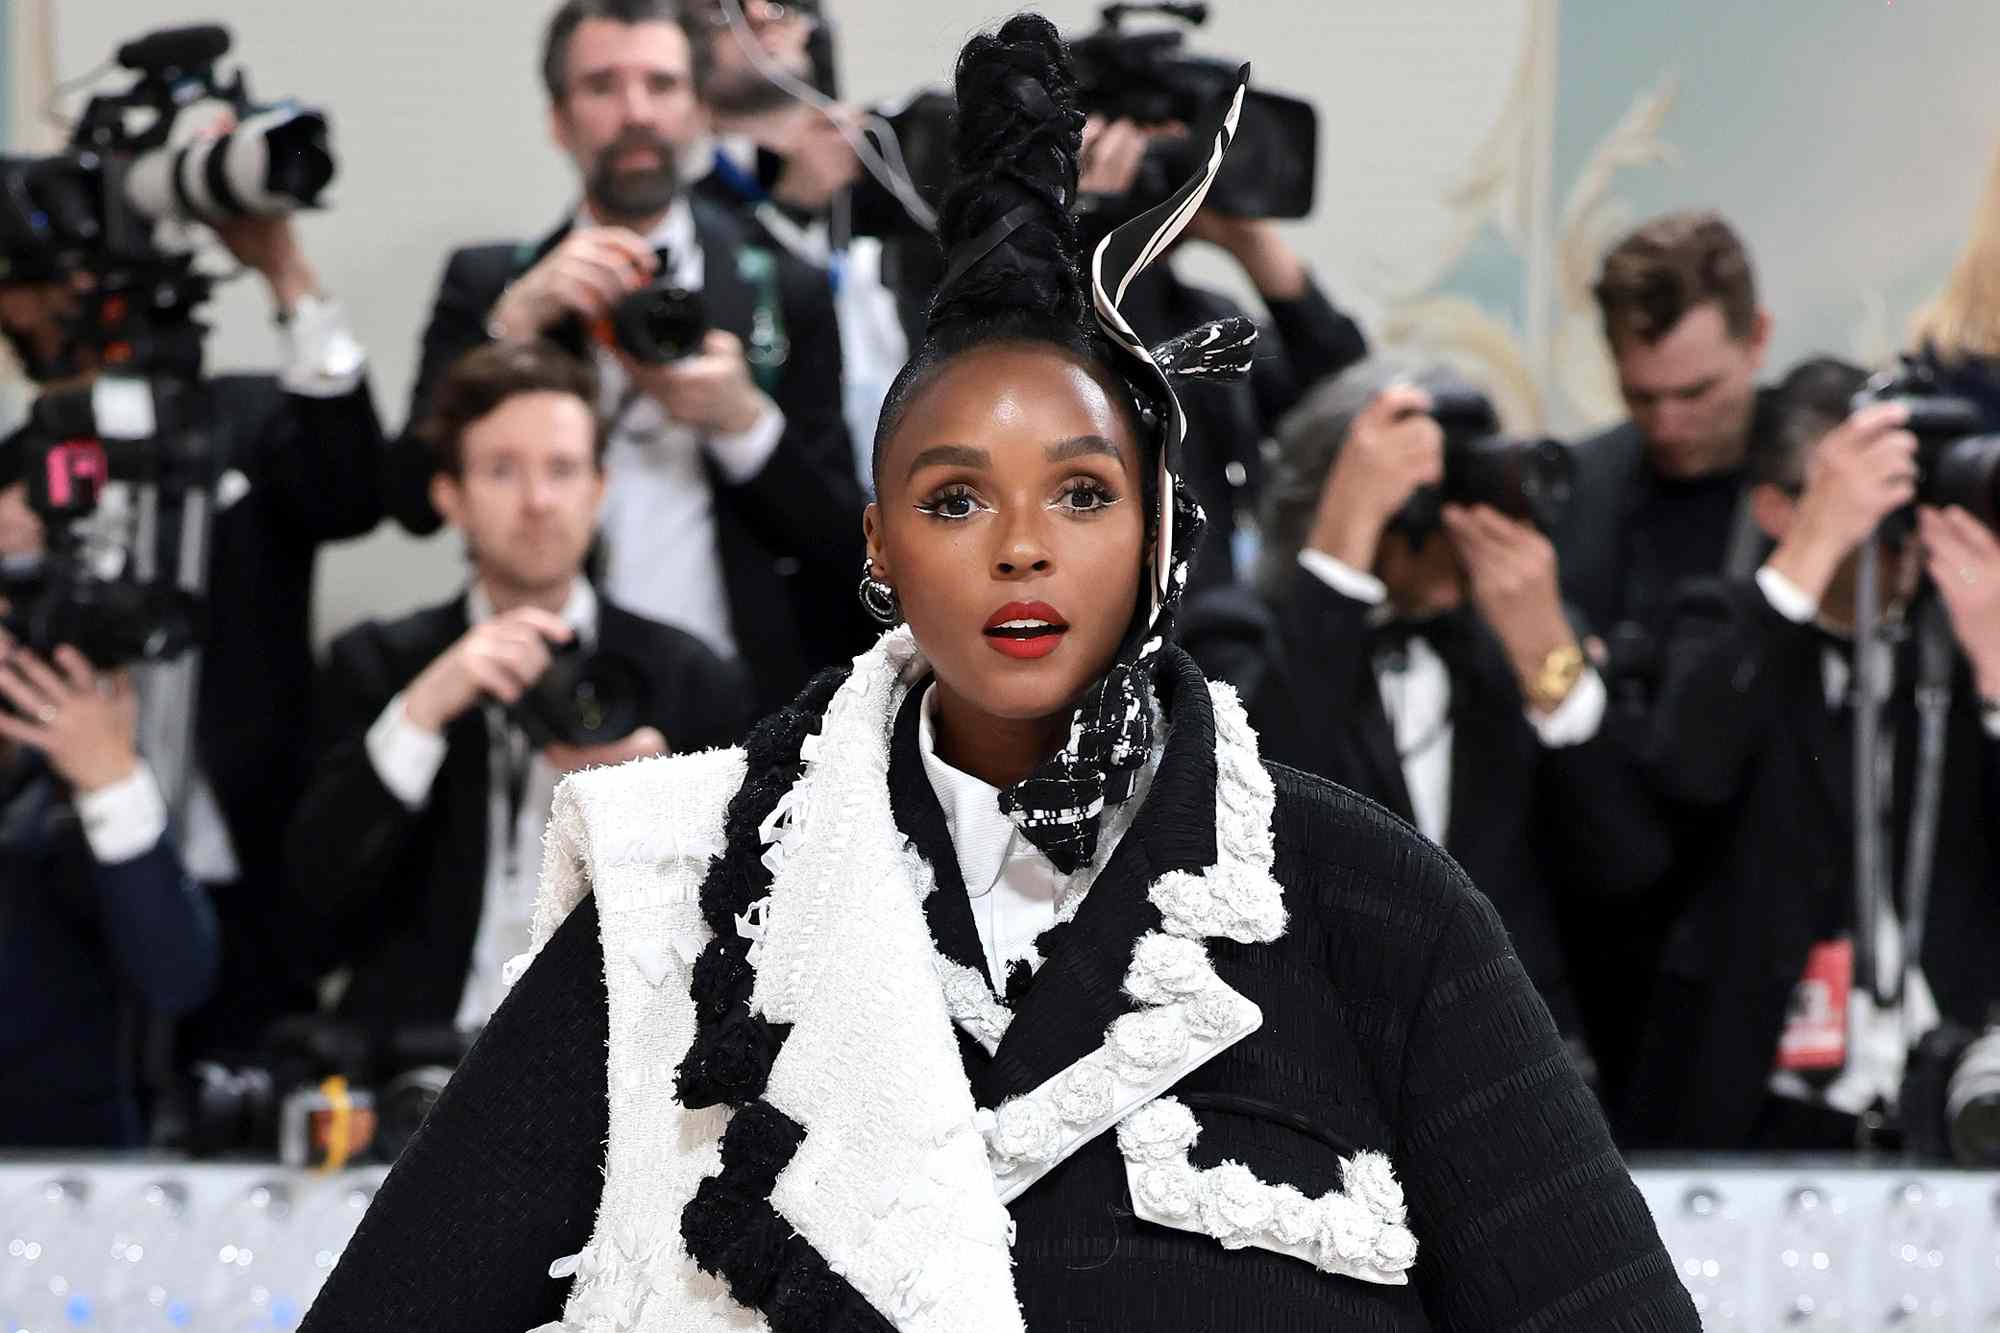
[366,578,598,1031]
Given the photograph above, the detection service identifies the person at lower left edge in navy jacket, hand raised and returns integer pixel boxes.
[0,632,218,1149]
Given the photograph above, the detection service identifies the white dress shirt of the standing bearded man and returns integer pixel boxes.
[576,198,784,656]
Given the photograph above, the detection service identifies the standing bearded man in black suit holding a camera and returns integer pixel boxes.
[390,0,868,711]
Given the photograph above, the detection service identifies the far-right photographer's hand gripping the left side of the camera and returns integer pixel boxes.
[1768,402,1916,600]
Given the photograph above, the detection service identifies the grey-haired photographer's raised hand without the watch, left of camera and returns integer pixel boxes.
[1306,384,1444,570]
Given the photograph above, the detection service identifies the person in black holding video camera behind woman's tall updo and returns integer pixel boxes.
[1078,118,1368,588]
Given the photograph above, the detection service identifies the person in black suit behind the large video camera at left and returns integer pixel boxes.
[0,218,384,1059]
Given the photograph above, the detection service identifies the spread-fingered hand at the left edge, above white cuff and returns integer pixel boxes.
[0,632,138,793]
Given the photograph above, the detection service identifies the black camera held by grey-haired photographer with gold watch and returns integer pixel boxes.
[1398,386,1572,536]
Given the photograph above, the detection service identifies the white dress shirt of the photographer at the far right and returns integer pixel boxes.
[1756,564,1938,1115]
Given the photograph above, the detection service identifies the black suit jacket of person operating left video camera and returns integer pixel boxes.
[184,374,384,1053]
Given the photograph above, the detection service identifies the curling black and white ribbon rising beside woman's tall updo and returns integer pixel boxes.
[1090,64,1250,622]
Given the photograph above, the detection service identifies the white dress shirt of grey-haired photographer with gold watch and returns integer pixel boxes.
[1298,546,1610,845]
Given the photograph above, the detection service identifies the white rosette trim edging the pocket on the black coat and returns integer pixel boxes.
[1118,1097,1416,1287]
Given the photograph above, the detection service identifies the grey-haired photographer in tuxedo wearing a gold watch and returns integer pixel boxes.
[1182,360,1668,1047]
